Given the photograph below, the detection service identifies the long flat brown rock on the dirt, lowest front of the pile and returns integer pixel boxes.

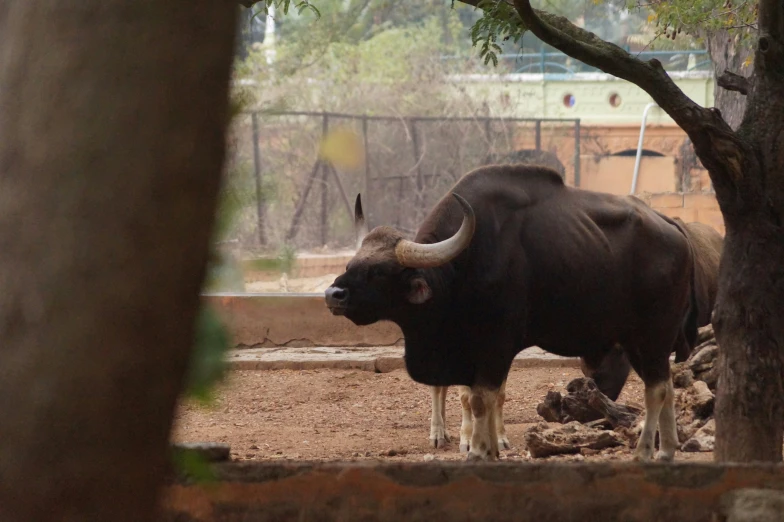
[525,421,623,458]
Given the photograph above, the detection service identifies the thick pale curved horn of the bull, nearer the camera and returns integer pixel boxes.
[395,193,476,268]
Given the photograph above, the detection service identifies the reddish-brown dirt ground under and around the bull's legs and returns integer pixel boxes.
[174,368,712,461]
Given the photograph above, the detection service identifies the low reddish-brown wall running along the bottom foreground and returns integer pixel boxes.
[163,462,784,522]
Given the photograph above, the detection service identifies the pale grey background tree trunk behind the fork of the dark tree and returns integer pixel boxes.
[705,29,754,129]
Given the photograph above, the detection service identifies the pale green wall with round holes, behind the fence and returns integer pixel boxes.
[451,71,714,125]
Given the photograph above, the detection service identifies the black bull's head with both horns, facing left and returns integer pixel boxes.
[325,193,476,325]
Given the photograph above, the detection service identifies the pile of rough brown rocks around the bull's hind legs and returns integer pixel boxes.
[525,326,719,458]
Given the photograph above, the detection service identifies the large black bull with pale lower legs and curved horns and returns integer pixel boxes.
[325,165,720,459]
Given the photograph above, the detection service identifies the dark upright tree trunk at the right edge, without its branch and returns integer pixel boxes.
[711,13,784,462]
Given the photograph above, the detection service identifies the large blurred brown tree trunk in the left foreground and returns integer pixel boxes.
[0,0,236,522]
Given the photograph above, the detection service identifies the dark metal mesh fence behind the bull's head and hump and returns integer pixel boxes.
[228,112,580,253]
